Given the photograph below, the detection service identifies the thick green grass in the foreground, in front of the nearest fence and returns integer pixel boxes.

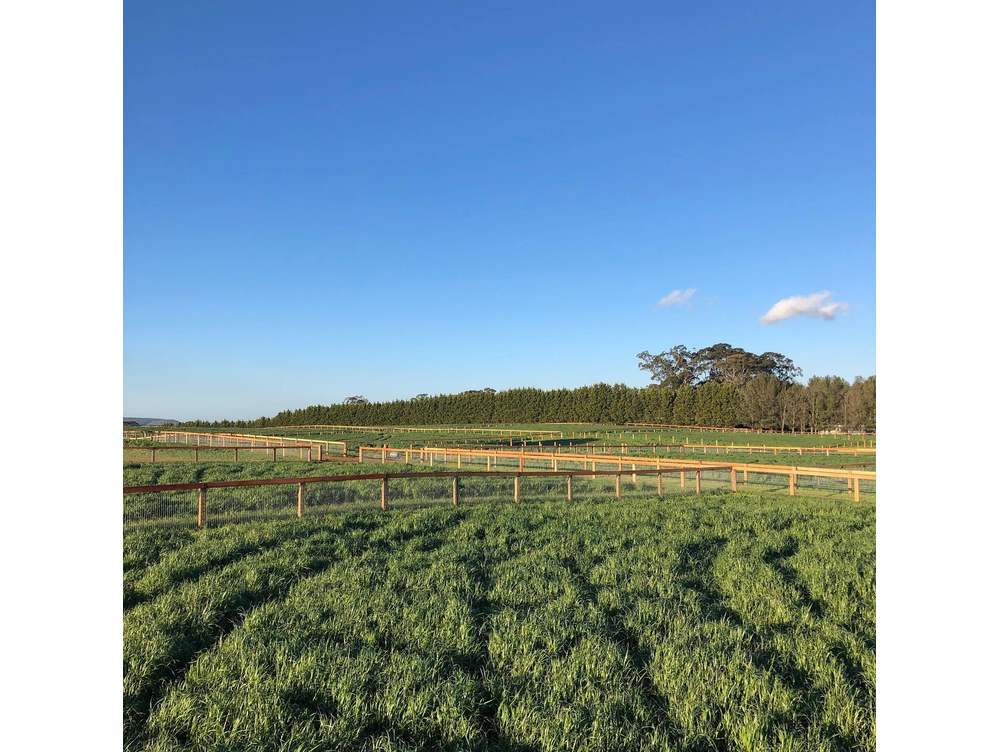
[124,494,875,752]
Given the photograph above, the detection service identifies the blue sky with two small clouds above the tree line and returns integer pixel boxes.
[124,0,875,419]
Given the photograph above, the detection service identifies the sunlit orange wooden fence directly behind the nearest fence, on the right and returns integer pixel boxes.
[358,446,875,501]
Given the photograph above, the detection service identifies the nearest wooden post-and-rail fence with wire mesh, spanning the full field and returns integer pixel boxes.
[124,467,875,531]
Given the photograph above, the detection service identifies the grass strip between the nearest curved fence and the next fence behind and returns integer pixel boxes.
[123,461,875,530]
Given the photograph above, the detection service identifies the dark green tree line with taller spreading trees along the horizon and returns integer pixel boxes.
[189,343,875,432]
